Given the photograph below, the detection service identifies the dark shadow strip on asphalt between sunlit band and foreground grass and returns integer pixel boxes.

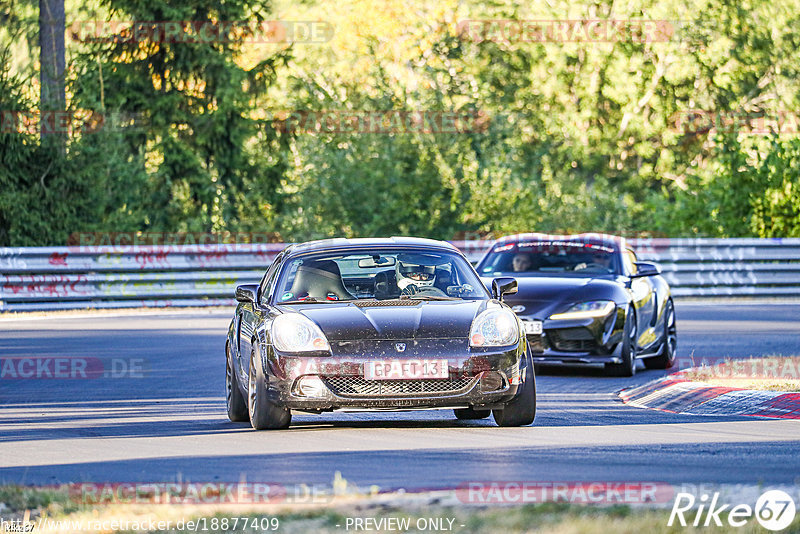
[0,442,800,491]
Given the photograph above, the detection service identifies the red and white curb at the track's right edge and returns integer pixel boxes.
[619,374,800,419]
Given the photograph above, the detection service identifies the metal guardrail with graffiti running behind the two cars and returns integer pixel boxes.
[0,238,800,311]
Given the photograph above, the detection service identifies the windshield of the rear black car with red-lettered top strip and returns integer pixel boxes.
[478,240,621,276]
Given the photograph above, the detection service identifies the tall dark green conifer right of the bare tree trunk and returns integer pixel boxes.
[67,0,284,231]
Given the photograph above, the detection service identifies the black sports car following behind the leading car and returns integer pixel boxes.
[477,234,677,376]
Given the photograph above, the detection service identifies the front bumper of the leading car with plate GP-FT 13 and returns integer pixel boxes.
[262,339,526,412]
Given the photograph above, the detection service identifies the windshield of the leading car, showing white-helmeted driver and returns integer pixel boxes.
[273,249,489,304]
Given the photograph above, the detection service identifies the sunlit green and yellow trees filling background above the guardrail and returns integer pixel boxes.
[0,0,800,245]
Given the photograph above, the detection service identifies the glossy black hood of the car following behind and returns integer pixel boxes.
[483,276,621,319]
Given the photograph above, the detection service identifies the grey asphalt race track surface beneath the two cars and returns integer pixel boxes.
[0,302,800,490]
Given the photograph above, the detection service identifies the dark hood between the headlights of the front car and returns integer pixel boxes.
[282,300,489,341]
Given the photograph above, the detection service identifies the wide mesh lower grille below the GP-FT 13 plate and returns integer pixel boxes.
[323,376,476,397]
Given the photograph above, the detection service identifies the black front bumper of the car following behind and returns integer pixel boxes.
[522,307,625,365]
